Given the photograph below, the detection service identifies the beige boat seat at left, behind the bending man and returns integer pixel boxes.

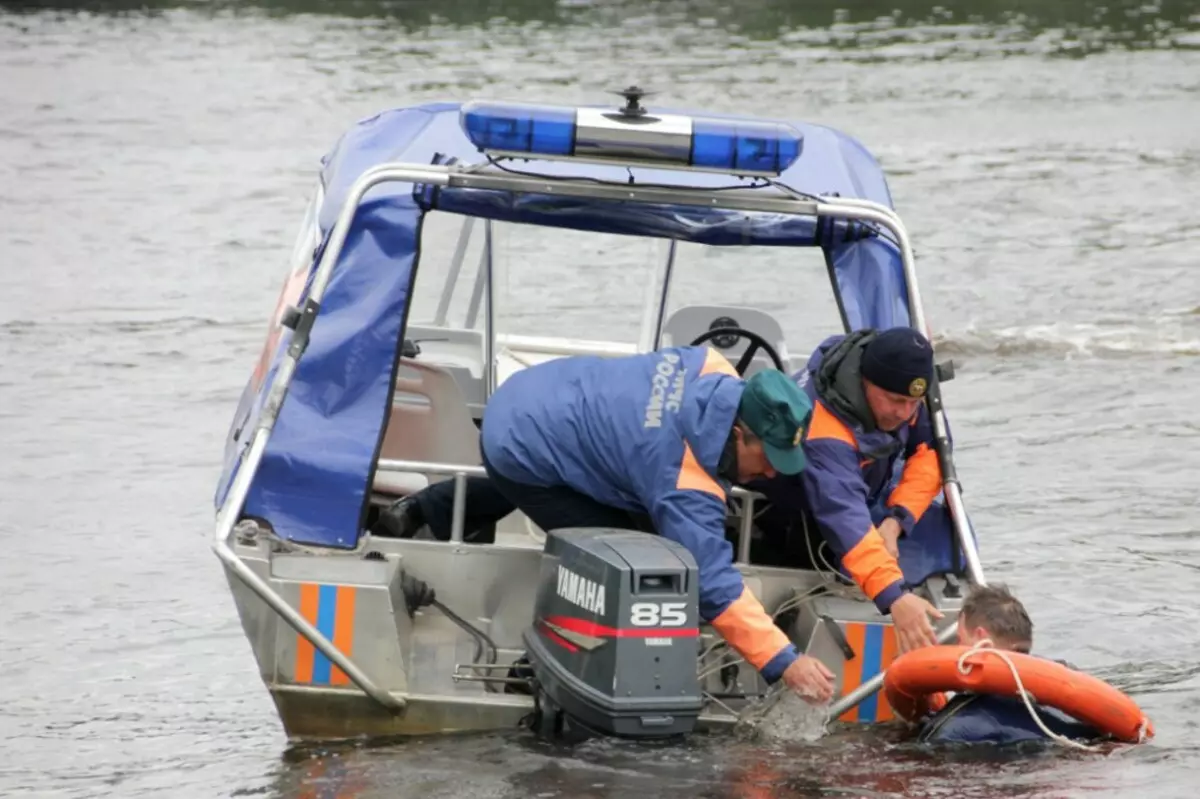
[373,358,481,495]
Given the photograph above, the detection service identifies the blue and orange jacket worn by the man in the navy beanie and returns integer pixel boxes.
[796,330,942,613]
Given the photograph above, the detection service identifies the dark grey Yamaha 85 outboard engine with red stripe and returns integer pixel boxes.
[524,528,703,738]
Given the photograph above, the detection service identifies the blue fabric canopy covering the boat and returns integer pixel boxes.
[216,103,910,548]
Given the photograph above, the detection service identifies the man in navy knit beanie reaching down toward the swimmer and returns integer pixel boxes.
[748,328,942,653]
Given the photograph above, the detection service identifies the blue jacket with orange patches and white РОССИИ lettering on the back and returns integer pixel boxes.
[481,347,799,683]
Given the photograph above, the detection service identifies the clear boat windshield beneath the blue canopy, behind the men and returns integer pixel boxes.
[409,205,841,385]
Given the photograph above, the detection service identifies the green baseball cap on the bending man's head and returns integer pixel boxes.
[738,370,812,474]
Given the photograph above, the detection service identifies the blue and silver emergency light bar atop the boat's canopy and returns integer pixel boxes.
[460,102,804,176]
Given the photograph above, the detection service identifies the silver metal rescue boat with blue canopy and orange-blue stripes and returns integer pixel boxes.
[214,89,984,740]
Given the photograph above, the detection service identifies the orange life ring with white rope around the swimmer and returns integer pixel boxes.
[883,647,1154,743]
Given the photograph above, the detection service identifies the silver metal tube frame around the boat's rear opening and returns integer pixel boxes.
[212,163,984,713]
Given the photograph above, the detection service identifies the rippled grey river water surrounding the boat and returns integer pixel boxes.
[0,0,1200,798]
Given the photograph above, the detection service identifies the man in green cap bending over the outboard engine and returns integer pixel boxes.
[480,347,833,703]
